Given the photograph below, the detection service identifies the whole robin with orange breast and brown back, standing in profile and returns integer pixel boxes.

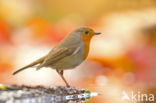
[13,27,101,87]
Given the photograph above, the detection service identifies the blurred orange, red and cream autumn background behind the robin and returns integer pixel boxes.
[0,0,156,103]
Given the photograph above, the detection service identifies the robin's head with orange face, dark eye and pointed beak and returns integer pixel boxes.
[74,27,101,41]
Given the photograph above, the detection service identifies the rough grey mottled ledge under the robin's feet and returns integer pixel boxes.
[0,84,98,103]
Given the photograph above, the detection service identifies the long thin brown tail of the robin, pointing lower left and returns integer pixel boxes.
[13,56,46,75]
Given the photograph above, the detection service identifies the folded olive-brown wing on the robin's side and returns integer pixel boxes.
[37,45,81,70]
